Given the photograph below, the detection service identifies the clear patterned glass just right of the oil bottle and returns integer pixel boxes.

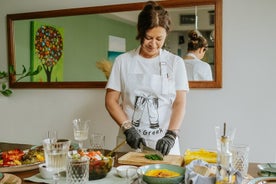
[231,144,249,177]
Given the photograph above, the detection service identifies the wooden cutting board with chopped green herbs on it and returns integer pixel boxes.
[118,152,184,166]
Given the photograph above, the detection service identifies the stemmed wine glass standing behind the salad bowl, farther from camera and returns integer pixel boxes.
[73,119,90,149]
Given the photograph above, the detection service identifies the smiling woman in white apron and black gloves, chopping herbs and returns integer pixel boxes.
[105,1,189,155]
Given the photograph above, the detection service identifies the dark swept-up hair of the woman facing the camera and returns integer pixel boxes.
[136,1,171,43]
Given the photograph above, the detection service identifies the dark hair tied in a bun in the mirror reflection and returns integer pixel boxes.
[188,30,208,51]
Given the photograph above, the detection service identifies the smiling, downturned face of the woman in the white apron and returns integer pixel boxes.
[140,27,167,58]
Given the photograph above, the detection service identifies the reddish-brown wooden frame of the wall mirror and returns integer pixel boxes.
[7,0,222,88]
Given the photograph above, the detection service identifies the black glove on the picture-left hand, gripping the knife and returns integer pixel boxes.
[124,127,146,149]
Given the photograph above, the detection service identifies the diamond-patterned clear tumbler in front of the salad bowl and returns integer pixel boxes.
[66,152,89,184]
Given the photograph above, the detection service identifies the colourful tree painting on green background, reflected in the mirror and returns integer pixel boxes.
[32,22,63,82]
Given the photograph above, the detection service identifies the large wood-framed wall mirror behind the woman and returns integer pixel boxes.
[7,0,222,88]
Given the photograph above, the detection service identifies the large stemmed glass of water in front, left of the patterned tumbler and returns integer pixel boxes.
[43,138,70,184]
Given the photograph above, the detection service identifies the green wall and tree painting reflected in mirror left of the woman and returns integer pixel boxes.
[14,14,138,82]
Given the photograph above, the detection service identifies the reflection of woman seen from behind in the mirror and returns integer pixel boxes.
[184,31,213,81]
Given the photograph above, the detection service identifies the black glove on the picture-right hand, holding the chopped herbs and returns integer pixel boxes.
[156,130,177,155]
